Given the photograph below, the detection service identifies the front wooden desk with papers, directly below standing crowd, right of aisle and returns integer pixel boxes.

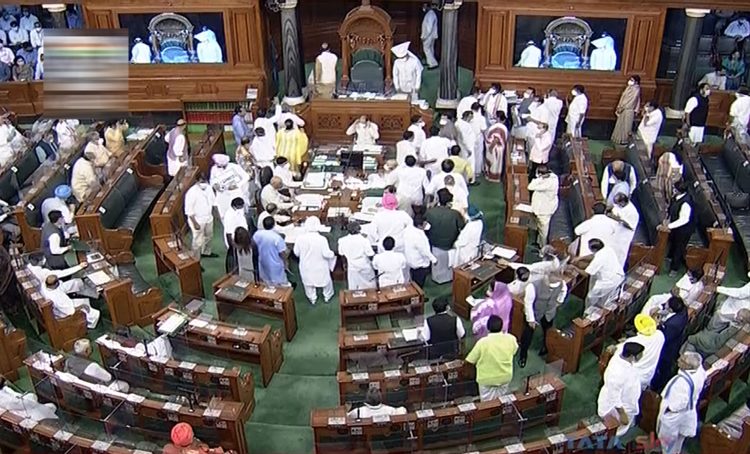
[339,282,424,327]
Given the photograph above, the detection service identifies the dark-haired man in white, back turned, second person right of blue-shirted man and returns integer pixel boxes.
[338,221,375,290]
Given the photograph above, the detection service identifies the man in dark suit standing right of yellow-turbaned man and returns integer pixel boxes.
[651,296,688,392]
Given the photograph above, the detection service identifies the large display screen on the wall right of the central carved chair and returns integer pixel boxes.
[513,16,628,71]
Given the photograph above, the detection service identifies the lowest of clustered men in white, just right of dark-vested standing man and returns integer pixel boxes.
[582,238,625,308]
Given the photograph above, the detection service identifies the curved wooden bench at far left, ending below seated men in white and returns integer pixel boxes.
[9,245,86,351]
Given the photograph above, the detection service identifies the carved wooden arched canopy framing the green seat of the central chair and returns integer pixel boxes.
[339,0,395,86]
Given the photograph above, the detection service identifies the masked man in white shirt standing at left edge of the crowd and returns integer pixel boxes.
[184,174,216,260]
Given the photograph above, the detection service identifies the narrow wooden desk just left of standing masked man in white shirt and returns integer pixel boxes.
[148,166,200,236]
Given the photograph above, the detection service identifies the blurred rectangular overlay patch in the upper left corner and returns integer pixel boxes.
[44,29,129,118]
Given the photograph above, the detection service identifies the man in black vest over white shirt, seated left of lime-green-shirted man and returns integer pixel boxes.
[422,298,466,359]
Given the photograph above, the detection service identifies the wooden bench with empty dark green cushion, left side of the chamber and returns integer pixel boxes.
[75,153,164,261]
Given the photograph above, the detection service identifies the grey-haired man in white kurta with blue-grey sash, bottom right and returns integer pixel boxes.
[656,352,706,454]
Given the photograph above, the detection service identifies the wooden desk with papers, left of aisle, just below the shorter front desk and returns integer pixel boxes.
[154,304,284,386]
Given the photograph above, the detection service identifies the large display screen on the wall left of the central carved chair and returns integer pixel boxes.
[120,13,226,64]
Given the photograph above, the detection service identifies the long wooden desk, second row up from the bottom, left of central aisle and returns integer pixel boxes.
[96,334,255,418]
